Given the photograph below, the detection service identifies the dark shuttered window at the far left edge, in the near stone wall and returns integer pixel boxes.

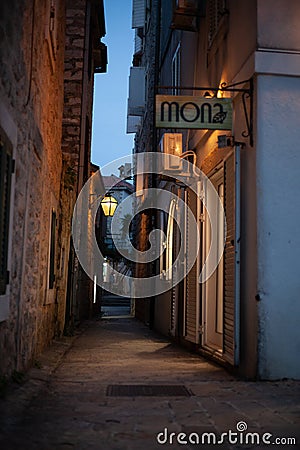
[0,128,13,295]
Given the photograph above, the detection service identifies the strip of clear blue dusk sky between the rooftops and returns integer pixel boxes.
[92,0,134,167]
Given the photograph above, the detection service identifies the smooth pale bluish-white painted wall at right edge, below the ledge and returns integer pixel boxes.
[256,74,300,379]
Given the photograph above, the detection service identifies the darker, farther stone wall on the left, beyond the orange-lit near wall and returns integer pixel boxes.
[61,0,104,328]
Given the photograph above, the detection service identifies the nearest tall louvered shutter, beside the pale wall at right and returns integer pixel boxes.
[223,148,240,365]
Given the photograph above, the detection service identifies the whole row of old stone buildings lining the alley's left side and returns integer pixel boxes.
[0,0,106,374]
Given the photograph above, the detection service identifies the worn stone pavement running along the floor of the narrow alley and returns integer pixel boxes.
[0,318,300,450]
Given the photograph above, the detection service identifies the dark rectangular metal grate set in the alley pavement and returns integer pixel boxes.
[106,384,194,397]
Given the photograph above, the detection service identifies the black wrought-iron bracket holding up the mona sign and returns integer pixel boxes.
[155,78,253,147]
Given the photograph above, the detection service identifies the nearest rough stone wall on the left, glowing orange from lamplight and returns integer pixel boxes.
[0,0,65,374]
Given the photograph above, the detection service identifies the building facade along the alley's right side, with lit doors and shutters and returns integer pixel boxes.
[128,0,300,379]
